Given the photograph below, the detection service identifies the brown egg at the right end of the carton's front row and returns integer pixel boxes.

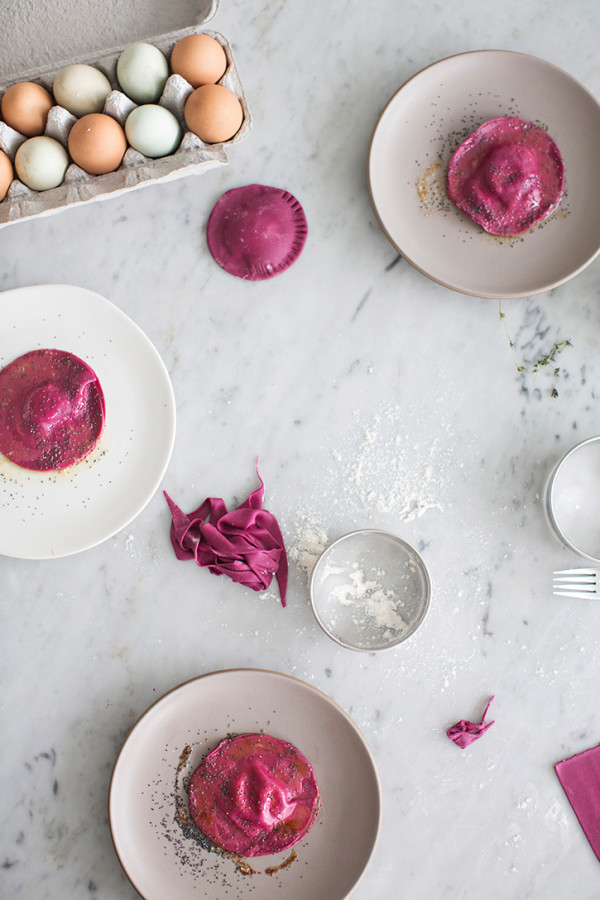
[183,84,244,144]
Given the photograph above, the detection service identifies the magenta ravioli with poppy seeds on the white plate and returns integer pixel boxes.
[0,350,105,471]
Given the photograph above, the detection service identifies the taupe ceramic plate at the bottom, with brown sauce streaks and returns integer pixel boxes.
[109,669,381,900]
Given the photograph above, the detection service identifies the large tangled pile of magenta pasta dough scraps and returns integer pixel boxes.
[164,469,288,606]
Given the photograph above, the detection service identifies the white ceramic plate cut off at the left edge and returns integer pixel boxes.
[0,285,175,559]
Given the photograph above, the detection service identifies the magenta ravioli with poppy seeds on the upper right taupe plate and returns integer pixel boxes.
[447,116,564,235]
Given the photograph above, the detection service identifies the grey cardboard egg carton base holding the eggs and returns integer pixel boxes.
[0,26,252,228]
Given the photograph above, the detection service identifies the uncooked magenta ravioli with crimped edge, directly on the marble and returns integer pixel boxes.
[206,184,308,281]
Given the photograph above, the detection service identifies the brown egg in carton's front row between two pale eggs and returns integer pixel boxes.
[69,113,127,175]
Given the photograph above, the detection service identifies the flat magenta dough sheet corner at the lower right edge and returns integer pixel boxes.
[554,746,600,860]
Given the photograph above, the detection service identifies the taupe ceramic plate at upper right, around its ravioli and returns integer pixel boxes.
[368,50,600,299]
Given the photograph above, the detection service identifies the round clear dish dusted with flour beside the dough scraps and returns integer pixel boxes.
[310,529,431,651]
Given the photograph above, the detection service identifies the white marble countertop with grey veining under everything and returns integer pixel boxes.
[0,0,600,900]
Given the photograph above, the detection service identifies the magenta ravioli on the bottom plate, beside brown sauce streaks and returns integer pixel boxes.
[189,734,320,856]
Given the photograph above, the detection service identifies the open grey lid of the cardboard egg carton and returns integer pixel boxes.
[0,0,219,83]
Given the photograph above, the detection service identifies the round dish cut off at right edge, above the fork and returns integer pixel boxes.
[546,436,600,562]
